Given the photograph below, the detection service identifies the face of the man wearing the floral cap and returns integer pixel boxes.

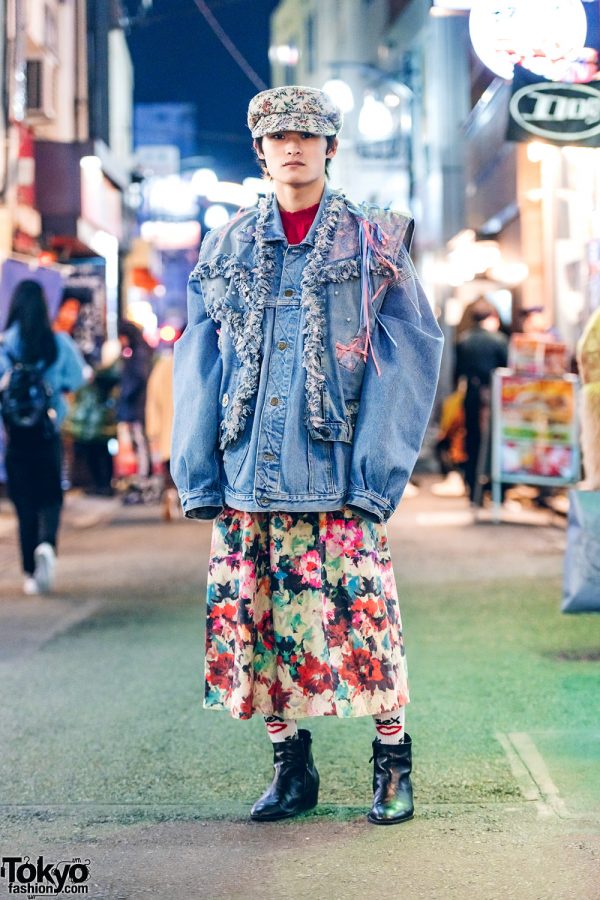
[257,131,337,187]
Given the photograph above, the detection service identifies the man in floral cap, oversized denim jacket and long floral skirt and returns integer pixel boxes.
[172,86,442,824]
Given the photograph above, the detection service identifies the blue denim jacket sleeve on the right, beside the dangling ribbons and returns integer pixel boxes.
[346,247,443,522]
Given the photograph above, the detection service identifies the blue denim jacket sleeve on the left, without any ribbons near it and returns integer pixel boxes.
[171,272,223,519]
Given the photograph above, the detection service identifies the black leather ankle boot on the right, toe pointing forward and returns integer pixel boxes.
[368,734,414,825]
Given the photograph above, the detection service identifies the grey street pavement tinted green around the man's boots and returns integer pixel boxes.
[0,486,600,900]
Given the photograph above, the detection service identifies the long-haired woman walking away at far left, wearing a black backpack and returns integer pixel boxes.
[0,280,85,594]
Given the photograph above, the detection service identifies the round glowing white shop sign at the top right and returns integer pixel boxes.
[469,0,587,79]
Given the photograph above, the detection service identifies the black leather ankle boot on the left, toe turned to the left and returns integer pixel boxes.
[250,728,319,822]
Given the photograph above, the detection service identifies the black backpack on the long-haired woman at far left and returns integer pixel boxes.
[0,348,53,434]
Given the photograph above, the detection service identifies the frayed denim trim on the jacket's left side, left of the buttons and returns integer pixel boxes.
[217,198,275,450]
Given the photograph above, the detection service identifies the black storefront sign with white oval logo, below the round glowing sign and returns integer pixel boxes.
[507,66,600,147]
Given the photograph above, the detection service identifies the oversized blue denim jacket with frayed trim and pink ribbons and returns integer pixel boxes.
[171,188,442,521]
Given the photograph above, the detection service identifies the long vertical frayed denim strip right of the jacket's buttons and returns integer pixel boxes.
[300,194,344,428]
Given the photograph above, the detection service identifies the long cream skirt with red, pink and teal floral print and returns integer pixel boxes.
[204,507,409,719]
